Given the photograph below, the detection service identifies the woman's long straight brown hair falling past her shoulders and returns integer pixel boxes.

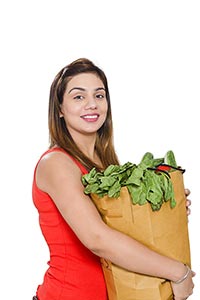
[48,58,119,170]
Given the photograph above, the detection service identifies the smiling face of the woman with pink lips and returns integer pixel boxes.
[61,73,108,137]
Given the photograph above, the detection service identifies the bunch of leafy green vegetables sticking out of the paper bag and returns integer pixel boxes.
[82,150,181,211]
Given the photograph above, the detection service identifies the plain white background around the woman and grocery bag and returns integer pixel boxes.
[0,0,200,300]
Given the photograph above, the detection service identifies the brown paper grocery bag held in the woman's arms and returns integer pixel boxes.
[91,171,191,300]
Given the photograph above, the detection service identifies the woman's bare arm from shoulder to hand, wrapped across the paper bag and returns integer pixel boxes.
[36,152,193,299]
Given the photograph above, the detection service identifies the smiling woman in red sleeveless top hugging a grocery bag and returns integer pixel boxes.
[33,59,194,300]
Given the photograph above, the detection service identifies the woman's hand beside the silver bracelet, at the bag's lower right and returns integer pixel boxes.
[171,270,195,300]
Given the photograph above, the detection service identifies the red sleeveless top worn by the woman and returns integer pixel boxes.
[32,148,107,300]
